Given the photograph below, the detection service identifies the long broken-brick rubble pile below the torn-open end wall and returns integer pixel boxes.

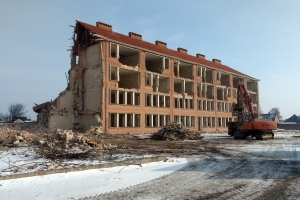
[0,124,117,160]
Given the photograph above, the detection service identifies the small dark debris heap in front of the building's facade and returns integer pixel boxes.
[151,122,201,141]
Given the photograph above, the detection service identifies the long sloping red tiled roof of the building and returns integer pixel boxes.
[77,21,252,78]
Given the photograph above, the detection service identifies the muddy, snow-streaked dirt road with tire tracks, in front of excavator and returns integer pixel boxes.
[86,134,300,199]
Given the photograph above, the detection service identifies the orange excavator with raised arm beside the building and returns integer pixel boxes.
[228,79,277,140]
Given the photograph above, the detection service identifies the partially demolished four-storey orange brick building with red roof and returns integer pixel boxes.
[34,21,259,134]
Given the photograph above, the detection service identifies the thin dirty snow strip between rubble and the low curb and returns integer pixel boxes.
[0,147,154,176]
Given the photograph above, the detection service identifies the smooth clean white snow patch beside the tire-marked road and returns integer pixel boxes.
[0,158,187,200]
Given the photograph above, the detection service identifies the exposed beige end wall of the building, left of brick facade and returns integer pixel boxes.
[43,43,103,131]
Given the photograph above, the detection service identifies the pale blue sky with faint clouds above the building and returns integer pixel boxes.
[0,0,300,119]
